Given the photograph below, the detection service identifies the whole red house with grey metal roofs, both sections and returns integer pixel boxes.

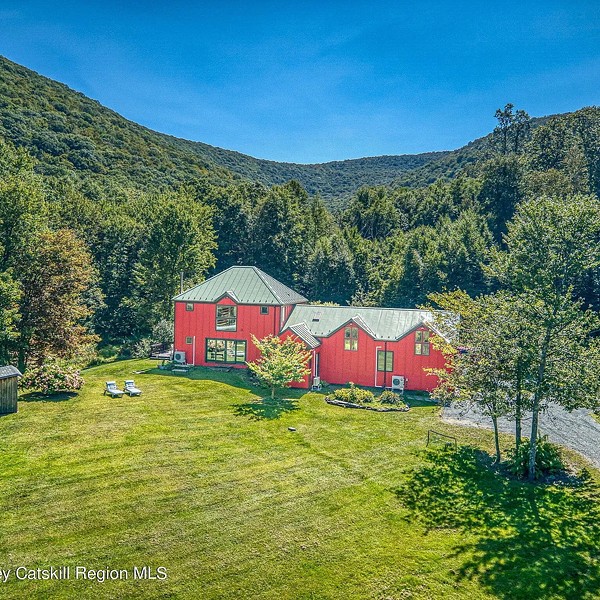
[174,266,444,391]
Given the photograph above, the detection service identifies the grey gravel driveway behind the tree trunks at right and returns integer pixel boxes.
[442,403,600,468]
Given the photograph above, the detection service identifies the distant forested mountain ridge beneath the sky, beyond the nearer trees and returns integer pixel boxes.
[0,57,516,207]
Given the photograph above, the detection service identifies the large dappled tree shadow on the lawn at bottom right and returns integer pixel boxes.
[396,447,600,600]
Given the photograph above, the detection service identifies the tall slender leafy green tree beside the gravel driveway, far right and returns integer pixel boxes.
[490,196,600,480]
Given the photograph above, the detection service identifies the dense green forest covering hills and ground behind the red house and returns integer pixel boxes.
[0,54,600,368]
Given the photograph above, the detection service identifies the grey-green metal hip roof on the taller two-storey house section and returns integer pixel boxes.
[174,266,307,305]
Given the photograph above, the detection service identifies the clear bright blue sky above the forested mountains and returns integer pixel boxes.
[0,0,600,163]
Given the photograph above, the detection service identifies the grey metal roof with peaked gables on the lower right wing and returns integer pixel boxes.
[284,304,431,342]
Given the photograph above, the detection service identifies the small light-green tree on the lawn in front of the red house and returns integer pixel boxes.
[246,335,310,398]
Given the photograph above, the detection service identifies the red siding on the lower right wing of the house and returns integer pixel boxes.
[320,327,445,391]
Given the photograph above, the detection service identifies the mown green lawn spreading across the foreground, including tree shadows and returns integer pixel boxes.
[0,361,600,600]
